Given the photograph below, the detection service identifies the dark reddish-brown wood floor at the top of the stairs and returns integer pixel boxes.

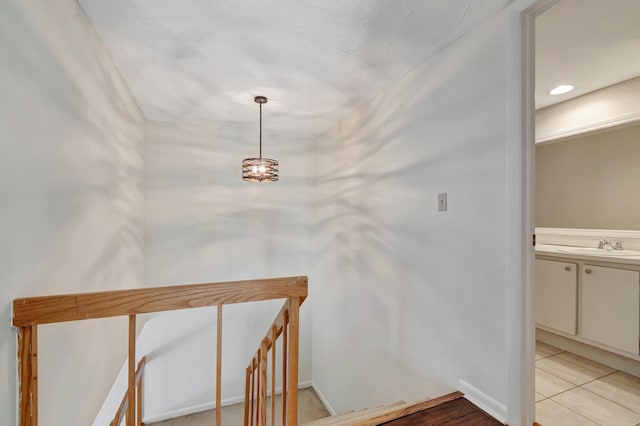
[382,397,502,426]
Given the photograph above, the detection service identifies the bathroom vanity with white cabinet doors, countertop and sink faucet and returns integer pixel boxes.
[535,230,640,361]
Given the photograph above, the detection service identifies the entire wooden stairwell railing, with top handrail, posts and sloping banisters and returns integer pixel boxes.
[12,277,308,426]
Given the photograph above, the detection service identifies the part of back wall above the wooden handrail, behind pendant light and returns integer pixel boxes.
[146,123,310,285]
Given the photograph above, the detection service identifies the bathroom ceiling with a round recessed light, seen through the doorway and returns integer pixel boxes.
[536,0,640,108]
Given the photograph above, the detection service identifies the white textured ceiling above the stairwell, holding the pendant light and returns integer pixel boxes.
[79,0,510,137]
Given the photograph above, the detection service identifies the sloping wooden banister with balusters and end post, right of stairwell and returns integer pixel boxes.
[244,298,304,426]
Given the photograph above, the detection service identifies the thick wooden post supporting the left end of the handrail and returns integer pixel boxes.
[18,326,38,426]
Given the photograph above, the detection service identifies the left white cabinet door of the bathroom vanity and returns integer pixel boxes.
[535,259,578,335]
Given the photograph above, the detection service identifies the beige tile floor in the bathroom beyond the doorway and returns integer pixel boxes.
[536,342,640,426]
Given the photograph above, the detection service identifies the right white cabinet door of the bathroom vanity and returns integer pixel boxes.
[582,265,640,354]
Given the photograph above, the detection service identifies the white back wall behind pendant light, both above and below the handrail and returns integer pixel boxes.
[139,121,314,418]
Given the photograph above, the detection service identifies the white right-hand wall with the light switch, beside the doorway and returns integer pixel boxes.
[310,12,507,416]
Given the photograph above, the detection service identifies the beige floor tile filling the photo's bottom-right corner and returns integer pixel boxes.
[543,388,640,426]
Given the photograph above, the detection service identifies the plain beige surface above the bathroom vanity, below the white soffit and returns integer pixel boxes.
[536,125,640,231]
